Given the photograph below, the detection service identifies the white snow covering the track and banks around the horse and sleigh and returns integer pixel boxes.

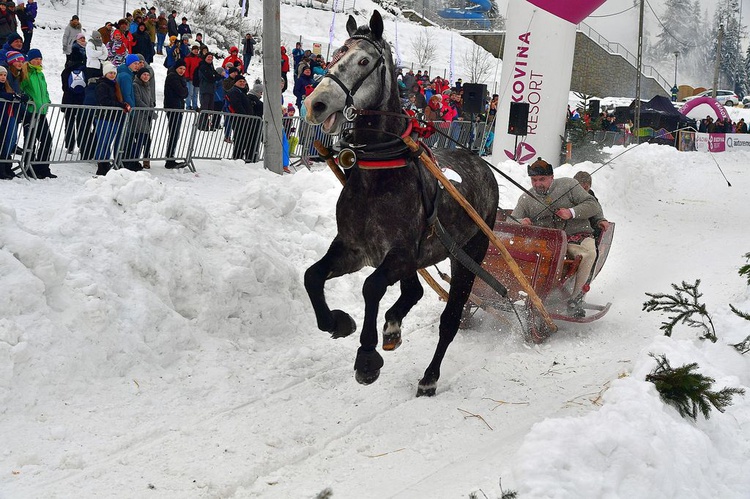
[0,0,750,499]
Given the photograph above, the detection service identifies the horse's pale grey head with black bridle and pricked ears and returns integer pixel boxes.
[305,11,398,133]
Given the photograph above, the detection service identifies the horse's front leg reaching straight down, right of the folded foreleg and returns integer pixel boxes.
[354,250,416,385]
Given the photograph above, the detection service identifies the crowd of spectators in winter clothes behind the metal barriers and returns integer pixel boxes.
[0,17,506,178]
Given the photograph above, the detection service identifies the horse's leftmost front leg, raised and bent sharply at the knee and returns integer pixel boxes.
[305,239,362,338]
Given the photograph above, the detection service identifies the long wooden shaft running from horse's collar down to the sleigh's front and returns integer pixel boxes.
[403,137,557,331]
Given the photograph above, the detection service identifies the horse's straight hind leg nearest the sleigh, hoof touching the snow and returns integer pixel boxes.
[417,232,489,397]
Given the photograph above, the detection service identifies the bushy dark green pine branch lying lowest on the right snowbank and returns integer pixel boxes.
[646,354,745,420]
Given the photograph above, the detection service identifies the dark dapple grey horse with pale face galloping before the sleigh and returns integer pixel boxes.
[304,11,498,396]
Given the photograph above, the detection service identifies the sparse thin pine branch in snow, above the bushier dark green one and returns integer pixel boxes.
[643,279,717,343]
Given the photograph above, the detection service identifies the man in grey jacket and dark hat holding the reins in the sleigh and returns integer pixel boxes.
[511,158,602,317]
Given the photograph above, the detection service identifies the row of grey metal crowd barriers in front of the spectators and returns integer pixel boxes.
[0,100,502,178]
